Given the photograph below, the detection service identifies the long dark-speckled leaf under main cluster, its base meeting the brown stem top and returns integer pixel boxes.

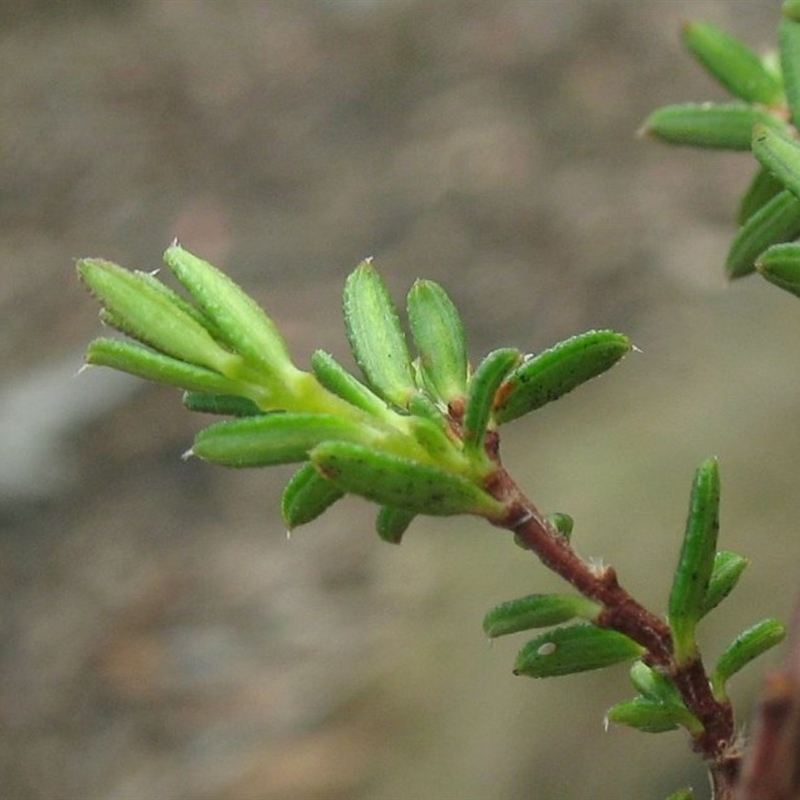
[311,441,504,519]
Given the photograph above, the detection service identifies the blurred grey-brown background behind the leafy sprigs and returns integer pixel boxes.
[0,0,800,800]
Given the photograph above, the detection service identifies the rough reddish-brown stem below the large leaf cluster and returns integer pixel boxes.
[487,467,740,800]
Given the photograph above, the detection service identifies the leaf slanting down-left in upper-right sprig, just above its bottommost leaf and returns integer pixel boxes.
[725,189,800,279]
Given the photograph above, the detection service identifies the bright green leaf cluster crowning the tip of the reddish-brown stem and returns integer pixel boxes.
[78,244,631,543]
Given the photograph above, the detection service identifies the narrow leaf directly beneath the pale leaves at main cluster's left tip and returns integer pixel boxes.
[86,338,242,394]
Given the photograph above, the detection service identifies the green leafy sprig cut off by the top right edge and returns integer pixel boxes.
[643,0,800,295]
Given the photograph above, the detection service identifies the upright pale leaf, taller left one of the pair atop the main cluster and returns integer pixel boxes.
[344,261,416,408]
